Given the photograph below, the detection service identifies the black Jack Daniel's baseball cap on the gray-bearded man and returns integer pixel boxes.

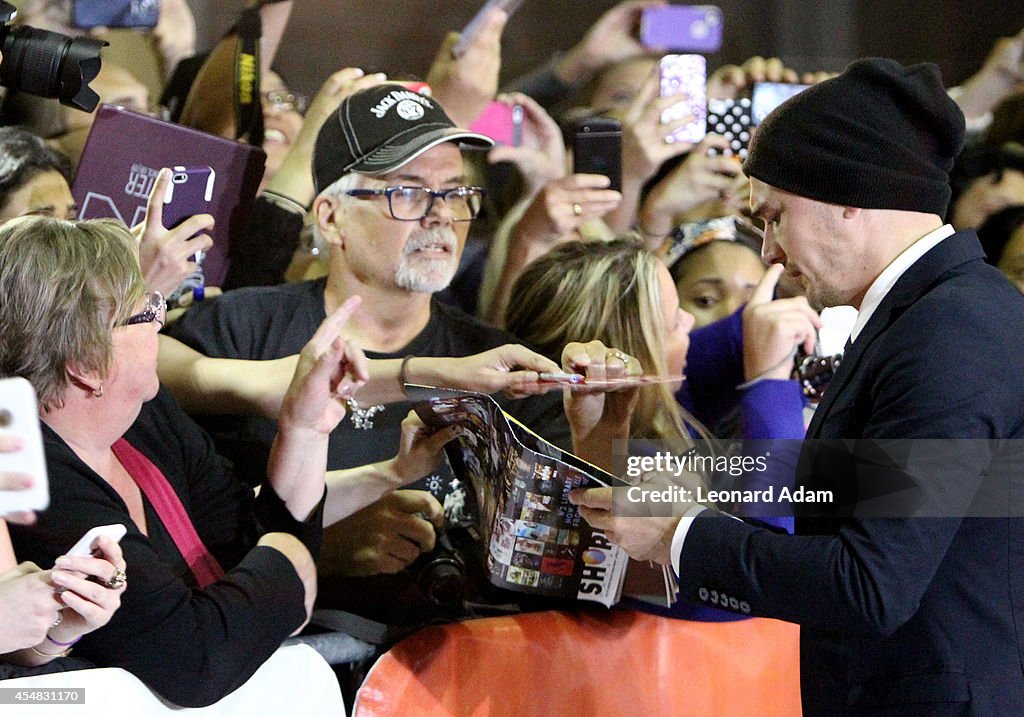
[313,83,494,192]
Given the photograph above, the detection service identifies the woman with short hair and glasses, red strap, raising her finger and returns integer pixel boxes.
[0,217,366,707]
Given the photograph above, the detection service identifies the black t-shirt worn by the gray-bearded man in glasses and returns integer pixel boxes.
[167,279,571,635]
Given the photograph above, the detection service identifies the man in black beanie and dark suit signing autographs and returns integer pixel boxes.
[579,59,1024,716]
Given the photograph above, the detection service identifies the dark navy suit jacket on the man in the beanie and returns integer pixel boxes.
[680,231,1024,716]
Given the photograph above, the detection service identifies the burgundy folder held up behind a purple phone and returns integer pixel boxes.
[72,104,266,286]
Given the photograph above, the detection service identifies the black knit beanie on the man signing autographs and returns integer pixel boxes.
[743,58,964,216]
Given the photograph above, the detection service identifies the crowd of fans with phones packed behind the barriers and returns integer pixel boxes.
[0,0,1024,706]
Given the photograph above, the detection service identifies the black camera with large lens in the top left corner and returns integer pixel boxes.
[0,2,108,112]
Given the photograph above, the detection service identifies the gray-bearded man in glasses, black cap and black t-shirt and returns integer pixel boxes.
[161,84,568,626]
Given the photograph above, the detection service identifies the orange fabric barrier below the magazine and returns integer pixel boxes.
[353,609,801,717]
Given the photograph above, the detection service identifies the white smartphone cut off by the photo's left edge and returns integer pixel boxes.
[0,377,50,517]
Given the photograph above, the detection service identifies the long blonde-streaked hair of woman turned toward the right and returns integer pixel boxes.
[505,237,707,448]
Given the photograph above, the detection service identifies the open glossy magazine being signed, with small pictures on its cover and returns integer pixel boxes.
[407,385,629,606]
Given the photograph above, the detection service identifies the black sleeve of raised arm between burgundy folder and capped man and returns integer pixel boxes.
[223,196,303,291]
